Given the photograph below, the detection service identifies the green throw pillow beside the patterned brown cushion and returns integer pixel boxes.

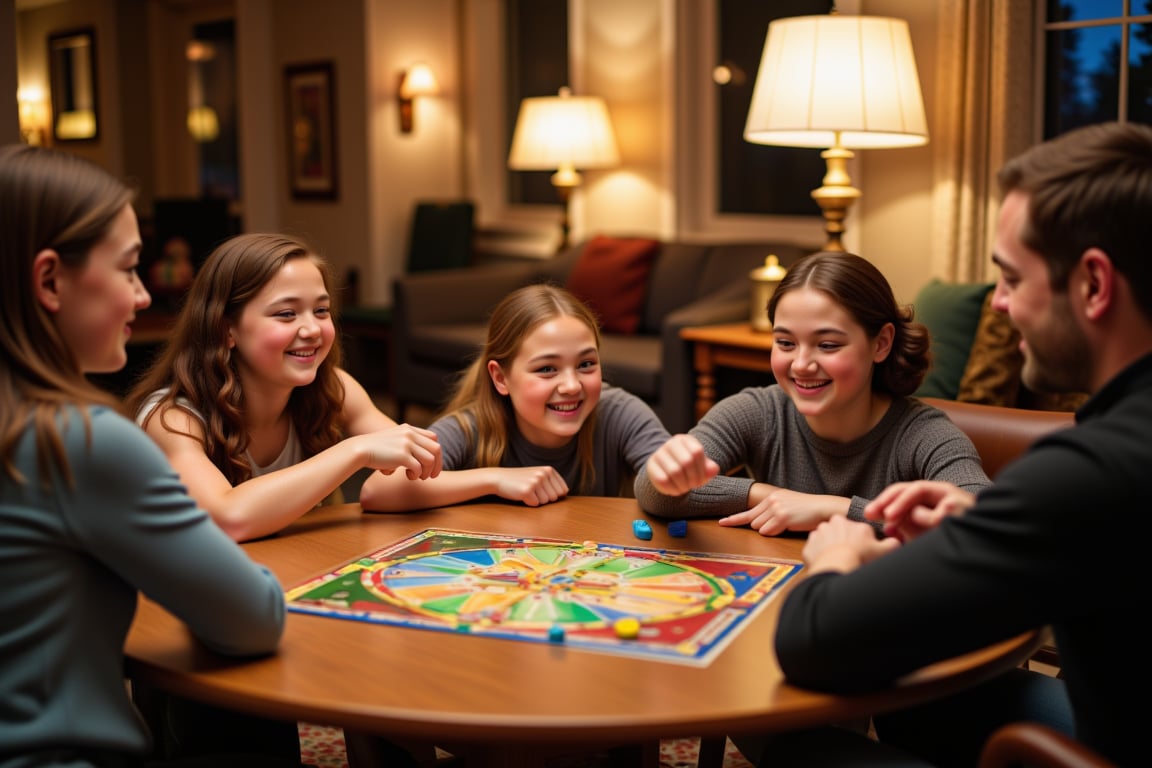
[916,277,993,400]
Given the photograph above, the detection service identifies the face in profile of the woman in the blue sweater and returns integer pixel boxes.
[54,205,152,373]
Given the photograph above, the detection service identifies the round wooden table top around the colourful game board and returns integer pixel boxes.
[127,497,1037,765]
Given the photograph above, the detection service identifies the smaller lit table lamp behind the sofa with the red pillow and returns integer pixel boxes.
[508,88,620,250]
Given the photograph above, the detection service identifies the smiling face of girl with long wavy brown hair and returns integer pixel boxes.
[228,258,336,390]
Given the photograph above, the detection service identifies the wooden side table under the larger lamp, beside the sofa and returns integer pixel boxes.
[680,322,772,420]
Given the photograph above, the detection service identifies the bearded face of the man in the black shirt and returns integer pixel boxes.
[992,191,1092,393]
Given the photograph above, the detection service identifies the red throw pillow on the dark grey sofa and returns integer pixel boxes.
[564,235,660,334]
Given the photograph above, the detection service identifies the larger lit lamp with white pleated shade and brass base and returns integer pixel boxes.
[744,12,929,251]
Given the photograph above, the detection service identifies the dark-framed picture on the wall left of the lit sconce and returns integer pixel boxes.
[285,61,339,200]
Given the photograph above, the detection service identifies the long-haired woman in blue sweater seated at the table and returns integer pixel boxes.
[0,145,285,768]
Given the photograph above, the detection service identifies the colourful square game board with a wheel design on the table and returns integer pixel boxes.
[287,529,801,667]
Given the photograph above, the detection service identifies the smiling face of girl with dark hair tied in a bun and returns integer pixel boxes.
[772,288,894,440]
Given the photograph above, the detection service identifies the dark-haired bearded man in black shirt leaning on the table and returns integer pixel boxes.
[766,123,1152,766]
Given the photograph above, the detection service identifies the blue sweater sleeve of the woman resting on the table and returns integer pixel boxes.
[68,410,285,655]
